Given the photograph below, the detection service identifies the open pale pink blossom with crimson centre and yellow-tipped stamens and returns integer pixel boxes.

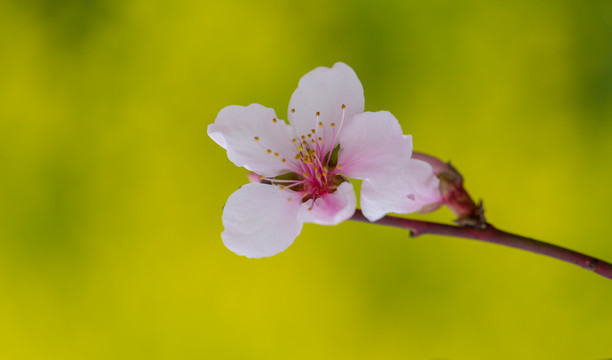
[208,63,439,258]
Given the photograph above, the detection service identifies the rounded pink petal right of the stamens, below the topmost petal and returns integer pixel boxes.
[338,111,412,183]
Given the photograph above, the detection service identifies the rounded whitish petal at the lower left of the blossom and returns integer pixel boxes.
[221,183,302,258]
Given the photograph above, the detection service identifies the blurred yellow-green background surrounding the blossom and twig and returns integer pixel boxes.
[0,0,612,359]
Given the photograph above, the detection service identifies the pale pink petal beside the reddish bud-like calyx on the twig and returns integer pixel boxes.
[361,159,442,221]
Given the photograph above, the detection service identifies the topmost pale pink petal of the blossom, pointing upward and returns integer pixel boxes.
[288,63,365,150]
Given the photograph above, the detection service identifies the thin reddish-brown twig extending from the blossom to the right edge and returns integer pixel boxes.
[351,210,612,279]
